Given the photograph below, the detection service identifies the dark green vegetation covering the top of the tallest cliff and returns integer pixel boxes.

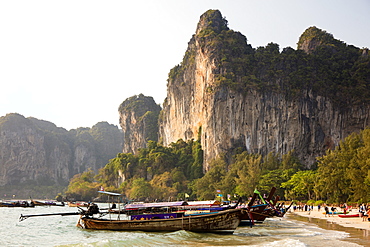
[169,10,370,107]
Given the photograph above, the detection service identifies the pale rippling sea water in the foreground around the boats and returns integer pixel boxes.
[0,206,370,247]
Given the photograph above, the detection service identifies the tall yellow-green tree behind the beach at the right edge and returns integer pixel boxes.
[315,129,370,202]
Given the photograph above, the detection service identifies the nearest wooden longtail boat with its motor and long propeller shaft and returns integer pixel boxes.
[19,192,246,234]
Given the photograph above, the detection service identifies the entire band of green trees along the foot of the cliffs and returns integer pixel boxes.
[66,129,370,203]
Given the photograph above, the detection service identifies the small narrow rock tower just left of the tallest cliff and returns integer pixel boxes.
[118,94,161,154]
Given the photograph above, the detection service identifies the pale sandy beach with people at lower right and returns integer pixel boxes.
[291,207,370,230]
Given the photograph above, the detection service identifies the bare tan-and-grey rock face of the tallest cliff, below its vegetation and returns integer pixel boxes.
[159,10,370,170]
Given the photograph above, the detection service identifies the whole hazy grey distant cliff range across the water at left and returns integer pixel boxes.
[0,113,122,186]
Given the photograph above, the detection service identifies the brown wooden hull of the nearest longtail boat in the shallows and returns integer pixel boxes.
[77,209,244,234]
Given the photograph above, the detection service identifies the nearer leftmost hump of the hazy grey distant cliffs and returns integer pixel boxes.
[0,114,72,185]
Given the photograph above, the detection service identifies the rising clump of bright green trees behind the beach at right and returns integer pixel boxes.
[282,129,370,203]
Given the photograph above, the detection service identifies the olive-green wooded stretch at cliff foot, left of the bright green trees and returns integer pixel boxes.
[66,135,303,201]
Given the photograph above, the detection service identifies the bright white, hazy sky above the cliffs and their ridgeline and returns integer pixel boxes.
[0,0,370,130]
